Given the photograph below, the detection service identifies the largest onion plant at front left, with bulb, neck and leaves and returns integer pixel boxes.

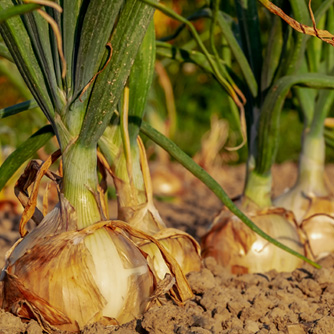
[0,0,192,331]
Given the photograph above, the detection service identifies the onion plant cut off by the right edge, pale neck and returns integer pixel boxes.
[275,7,334,258]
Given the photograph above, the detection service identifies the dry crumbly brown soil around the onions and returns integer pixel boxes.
[0,163,334,334]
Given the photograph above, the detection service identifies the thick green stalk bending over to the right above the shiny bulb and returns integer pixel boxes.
[202,73,334,270]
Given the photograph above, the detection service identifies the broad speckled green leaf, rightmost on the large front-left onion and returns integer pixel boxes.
[78,0,154,146]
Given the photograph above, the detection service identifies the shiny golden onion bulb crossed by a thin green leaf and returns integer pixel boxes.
[201,203,304,274]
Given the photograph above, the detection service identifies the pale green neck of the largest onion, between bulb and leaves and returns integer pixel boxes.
[63,143,101,229]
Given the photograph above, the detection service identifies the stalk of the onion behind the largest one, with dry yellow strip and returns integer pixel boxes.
[99,21,155,213]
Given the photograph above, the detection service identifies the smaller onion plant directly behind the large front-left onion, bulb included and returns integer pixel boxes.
[99,19,201,280]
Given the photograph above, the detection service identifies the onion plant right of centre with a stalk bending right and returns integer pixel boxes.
[198,1,333,272]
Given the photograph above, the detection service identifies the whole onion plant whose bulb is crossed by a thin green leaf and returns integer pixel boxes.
[147,1,332,272]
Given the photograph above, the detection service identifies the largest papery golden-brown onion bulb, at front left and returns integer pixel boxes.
[2,198,154,332]
